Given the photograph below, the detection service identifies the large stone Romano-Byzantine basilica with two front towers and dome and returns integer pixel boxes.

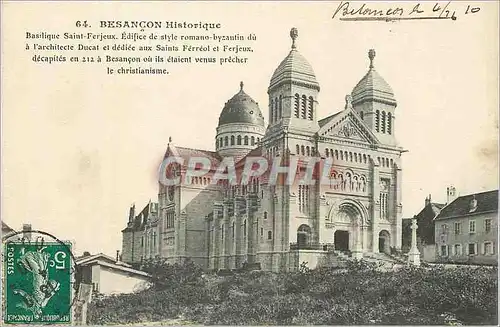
[122,28,405,271]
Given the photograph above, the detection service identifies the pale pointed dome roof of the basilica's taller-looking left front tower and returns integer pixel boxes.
[269,28,319,91]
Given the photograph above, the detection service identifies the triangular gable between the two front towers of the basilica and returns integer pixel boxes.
[318,109,379,144]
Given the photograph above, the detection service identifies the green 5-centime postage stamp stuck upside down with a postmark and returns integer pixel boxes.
[3,242,74,324]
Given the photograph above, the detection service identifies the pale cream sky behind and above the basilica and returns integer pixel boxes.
[1,2,498,255]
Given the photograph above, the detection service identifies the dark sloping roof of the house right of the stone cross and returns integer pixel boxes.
[435,190,498,220]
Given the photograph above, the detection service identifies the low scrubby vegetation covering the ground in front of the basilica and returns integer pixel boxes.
[88,261,498,325]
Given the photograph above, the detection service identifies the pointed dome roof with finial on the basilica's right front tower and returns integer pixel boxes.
[351,49,396,105]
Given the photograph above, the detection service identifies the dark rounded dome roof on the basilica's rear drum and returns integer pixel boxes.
[219,82,264,126]
